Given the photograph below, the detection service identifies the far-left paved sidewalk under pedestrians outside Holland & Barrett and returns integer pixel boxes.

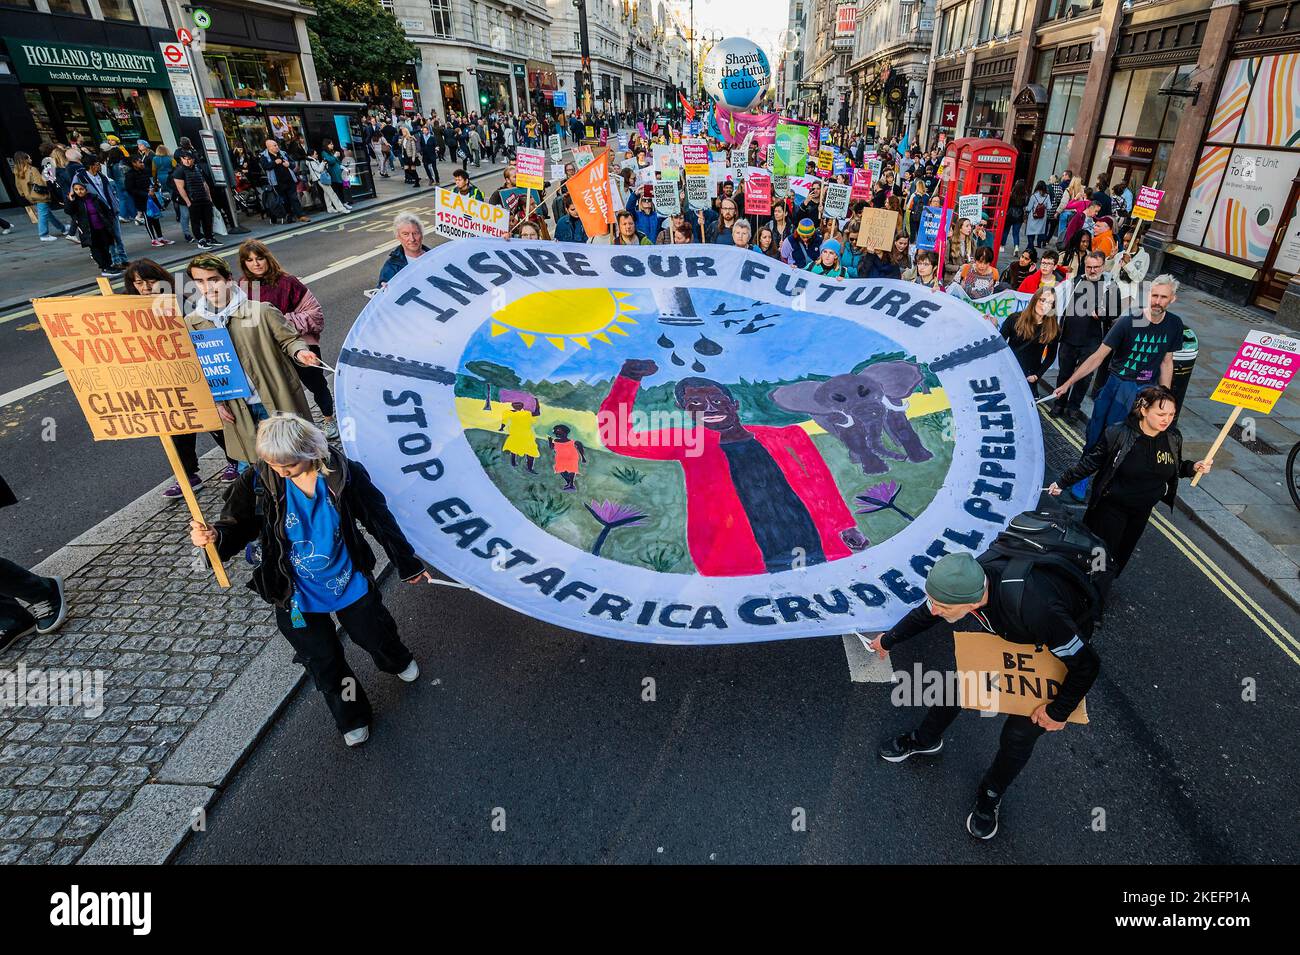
[0,160,506,311]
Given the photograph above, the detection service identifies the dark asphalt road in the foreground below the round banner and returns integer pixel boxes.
[178,501,1300,864]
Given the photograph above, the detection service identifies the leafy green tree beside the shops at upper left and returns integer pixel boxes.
[304,0,419,99]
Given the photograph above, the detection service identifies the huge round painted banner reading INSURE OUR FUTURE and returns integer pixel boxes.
[338,239,1043,643]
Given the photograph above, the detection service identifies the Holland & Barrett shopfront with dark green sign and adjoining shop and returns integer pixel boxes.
[0,0,321,205]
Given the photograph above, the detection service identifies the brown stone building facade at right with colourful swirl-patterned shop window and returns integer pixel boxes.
[923,0,1300,320]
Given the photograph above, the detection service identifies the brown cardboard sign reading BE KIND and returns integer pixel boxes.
[953,630,1088,724]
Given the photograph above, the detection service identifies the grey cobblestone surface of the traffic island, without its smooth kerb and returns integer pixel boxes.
[0,470,278,863]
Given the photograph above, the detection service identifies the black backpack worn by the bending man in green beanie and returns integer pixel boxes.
[978,511,1110,641]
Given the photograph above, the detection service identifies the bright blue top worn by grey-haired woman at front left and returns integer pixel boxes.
[285,474,369,613]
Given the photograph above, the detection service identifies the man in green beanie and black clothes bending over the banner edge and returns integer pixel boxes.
[868,554,1101,839]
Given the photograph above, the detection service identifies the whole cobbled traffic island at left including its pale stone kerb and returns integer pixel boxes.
[0,450,387,864]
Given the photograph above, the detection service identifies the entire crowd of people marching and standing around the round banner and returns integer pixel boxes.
[0,98,1210,838]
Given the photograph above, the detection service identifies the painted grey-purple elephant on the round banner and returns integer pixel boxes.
[772,361,933,474]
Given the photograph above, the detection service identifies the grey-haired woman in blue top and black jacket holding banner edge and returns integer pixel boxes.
[190,413,433,746]
